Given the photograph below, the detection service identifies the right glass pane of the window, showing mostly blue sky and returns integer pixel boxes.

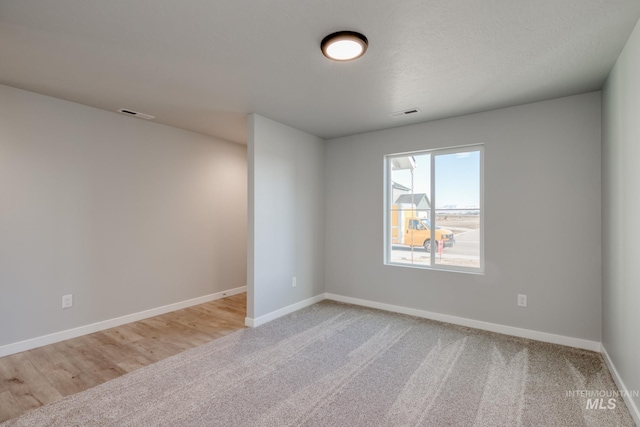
[434,151,482,268]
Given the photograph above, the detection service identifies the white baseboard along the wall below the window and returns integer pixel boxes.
[325,293,602,352]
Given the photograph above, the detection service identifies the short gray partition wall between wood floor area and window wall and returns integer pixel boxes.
[247,114,325,319]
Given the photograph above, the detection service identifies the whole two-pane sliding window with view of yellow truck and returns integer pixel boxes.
[385,145,484,273]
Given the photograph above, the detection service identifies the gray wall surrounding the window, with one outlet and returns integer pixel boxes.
[326,92,601,342]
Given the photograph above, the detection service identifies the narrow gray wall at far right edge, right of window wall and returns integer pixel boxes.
[602,19,640,414]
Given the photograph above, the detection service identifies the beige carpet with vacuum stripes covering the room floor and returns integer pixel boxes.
[1,301,634,427]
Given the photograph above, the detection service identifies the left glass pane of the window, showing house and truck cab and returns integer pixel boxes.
[387,154,431,266]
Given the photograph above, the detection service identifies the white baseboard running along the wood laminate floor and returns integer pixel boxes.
[0,286,247,357]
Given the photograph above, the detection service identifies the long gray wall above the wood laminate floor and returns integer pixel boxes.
[0,86,247,345]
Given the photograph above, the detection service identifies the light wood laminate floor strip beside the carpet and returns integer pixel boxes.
[0,293,247,422]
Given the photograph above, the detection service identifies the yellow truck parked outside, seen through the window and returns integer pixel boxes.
[391,209,456,252]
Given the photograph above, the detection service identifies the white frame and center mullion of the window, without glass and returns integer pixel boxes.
[383,144,485,274]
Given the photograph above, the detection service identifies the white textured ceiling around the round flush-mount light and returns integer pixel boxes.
[0,0,640,143]
